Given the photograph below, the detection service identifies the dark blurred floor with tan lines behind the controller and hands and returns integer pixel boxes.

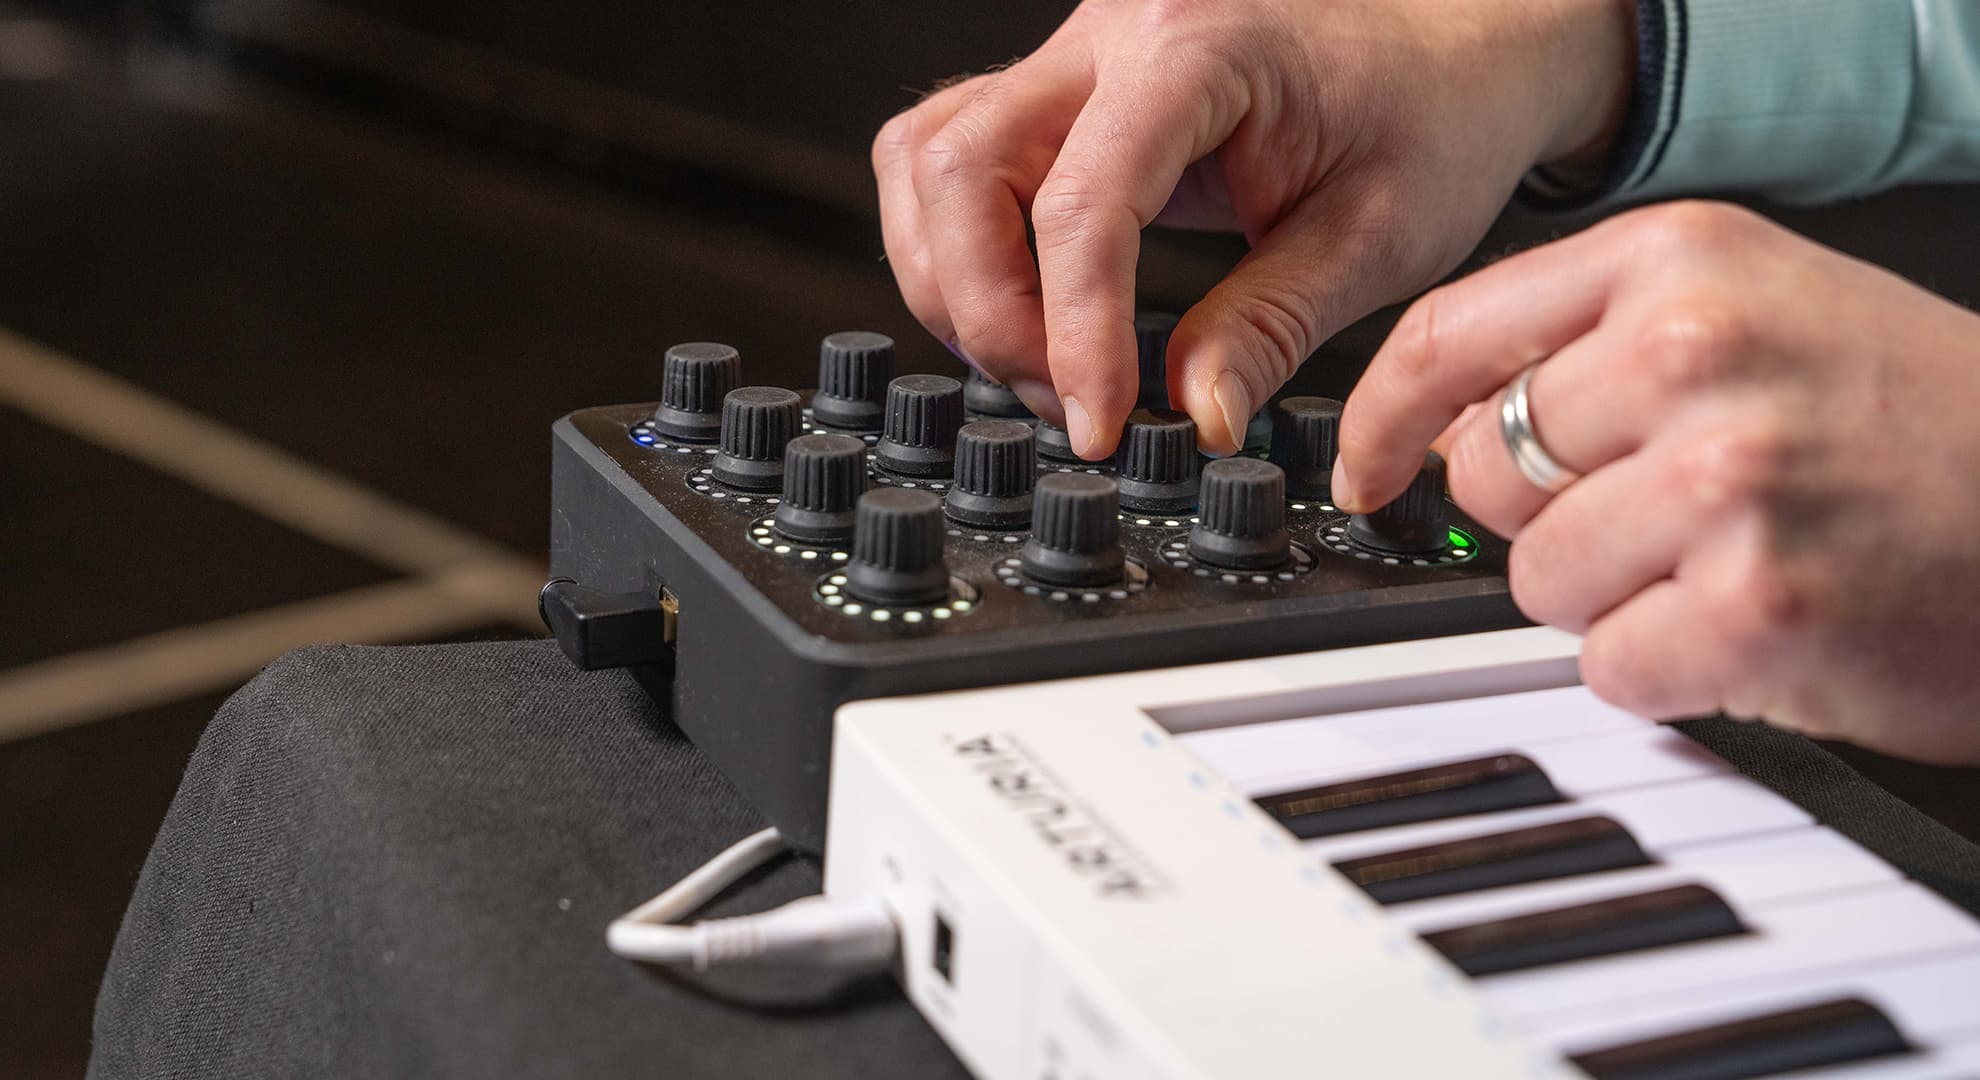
[0,0,1980,1076]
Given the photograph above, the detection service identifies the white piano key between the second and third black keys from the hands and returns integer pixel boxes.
[1388,826,1901,933]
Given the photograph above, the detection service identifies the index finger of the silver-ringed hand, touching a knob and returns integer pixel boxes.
[1333,226,1628,513]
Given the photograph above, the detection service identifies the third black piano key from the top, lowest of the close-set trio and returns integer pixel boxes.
[1424,886,1746,975]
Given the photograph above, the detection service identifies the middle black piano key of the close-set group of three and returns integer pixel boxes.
[1335,816,1653,904]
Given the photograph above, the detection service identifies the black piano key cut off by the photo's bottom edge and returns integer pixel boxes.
[1574,999,1913,1080]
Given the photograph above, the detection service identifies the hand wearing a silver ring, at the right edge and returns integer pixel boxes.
[1335,202,1980,761]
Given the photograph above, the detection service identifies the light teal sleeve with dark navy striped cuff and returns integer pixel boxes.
[1529,0,1980,204]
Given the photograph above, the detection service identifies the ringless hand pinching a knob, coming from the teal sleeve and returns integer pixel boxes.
[873,0,1634,458]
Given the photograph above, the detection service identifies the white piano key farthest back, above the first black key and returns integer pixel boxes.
[1180,686,1649,791]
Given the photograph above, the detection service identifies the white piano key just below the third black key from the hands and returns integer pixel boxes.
[1473,882,1980,1019]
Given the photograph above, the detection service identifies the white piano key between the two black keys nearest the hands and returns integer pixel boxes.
[1305,775,1814,862]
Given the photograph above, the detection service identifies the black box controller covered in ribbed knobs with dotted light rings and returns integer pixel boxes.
[543,319,1523,850]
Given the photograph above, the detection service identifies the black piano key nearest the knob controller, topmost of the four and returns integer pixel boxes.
[1257,753,1562,840]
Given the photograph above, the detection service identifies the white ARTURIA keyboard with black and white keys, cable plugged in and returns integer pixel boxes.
[826,628,1980,1080]
